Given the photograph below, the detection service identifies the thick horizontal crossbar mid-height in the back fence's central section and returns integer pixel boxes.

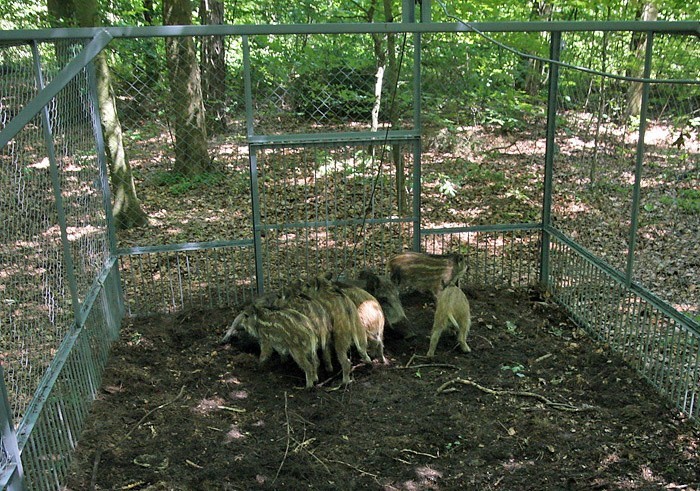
[248,130,420,147]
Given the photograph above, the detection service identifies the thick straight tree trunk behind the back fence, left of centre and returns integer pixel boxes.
[163,0,213,175]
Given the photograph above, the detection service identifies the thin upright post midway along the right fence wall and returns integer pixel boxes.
[625,32,654,288]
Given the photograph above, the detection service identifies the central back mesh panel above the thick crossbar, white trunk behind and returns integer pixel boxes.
[250,33,413,135]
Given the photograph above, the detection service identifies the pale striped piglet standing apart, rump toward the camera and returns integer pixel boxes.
[428,285,472,357]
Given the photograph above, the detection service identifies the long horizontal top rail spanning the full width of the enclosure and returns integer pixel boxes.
[0,21,700,41]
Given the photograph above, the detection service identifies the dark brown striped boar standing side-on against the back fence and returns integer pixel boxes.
[387,252,467,298]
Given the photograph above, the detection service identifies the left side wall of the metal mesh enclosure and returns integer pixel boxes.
[0,32,120,489]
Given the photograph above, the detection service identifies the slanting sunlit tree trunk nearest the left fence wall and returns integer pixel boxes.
[48,0,147,229]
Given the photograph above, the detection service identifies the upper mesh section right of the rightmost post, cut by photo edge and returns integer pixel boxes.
[633,35,700,319]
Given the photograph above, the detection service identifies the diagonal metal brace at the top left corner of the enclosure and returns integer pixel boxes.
[0,30,112,148]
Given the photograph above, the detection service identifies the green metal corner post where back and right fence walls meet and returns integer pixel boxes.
[540,31,561,289]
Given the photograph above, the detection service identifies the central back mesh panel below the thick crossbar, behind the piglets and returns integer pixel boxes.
[255,142,413,288]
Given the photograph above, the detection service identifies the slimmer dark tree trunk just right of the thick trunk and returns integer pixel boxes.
[199,0,226,133]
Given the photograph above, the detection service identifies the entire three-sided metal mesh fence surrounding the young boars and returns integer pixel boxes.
[0,24,700,489]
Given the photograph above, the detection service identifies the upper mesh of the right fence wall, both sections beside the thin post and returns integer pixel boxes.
[553,33,700,322]
